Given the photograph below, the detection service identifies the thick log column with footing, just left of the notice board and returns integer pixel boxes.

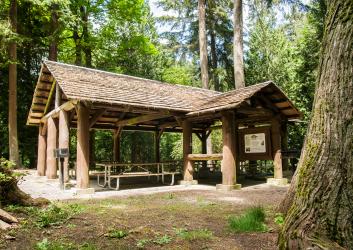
[216,111,241,191]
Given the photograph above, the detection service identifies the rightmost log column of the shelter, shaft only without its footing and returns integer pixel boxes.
[271,119,283,179]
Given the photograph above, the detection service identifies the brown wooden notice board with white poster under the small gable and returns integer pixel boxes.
[238,127,272,160]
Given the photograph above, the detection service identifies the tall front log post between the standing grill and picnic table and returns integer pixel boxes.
[76,103,89,188]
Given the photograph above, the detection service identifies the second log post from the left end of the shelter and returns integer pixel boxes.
[46,117,58,179]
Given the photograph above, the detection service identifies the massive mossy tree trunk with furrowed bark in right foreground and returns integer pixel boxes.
[279,0,353,249]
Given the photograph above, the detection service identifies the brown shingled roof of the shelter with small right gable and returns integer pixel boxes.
[27,61,300,125]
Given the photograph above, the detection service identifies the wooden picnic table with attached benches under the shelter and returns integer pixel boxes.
[94,162,180,190]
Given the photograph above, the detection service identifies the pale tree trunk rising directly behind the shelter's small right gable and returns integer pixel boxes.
[233,0,245,89]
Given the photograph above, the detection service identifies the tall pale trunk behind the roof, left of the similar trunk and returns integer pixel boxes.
[198,0,209,89]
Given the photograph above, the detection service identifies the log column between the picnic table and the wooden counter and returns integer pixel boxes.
[182,121,194,181]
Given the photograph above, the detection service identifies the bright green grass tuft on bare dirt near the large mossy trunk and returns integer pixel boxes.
[229,206,267,232]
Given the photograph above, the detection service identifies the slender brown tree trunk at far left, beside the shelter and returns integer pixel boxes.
[8,0,20,167]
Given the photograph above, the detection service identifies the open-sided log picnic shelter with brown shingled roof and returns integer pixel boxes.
[27,61,301,189]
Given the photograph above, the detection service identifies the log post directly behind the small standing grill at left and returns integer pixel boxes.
[59,110,70,182]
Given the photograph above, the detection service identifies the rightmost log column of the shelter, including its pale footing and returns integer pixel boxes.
[267,117,288,185]
